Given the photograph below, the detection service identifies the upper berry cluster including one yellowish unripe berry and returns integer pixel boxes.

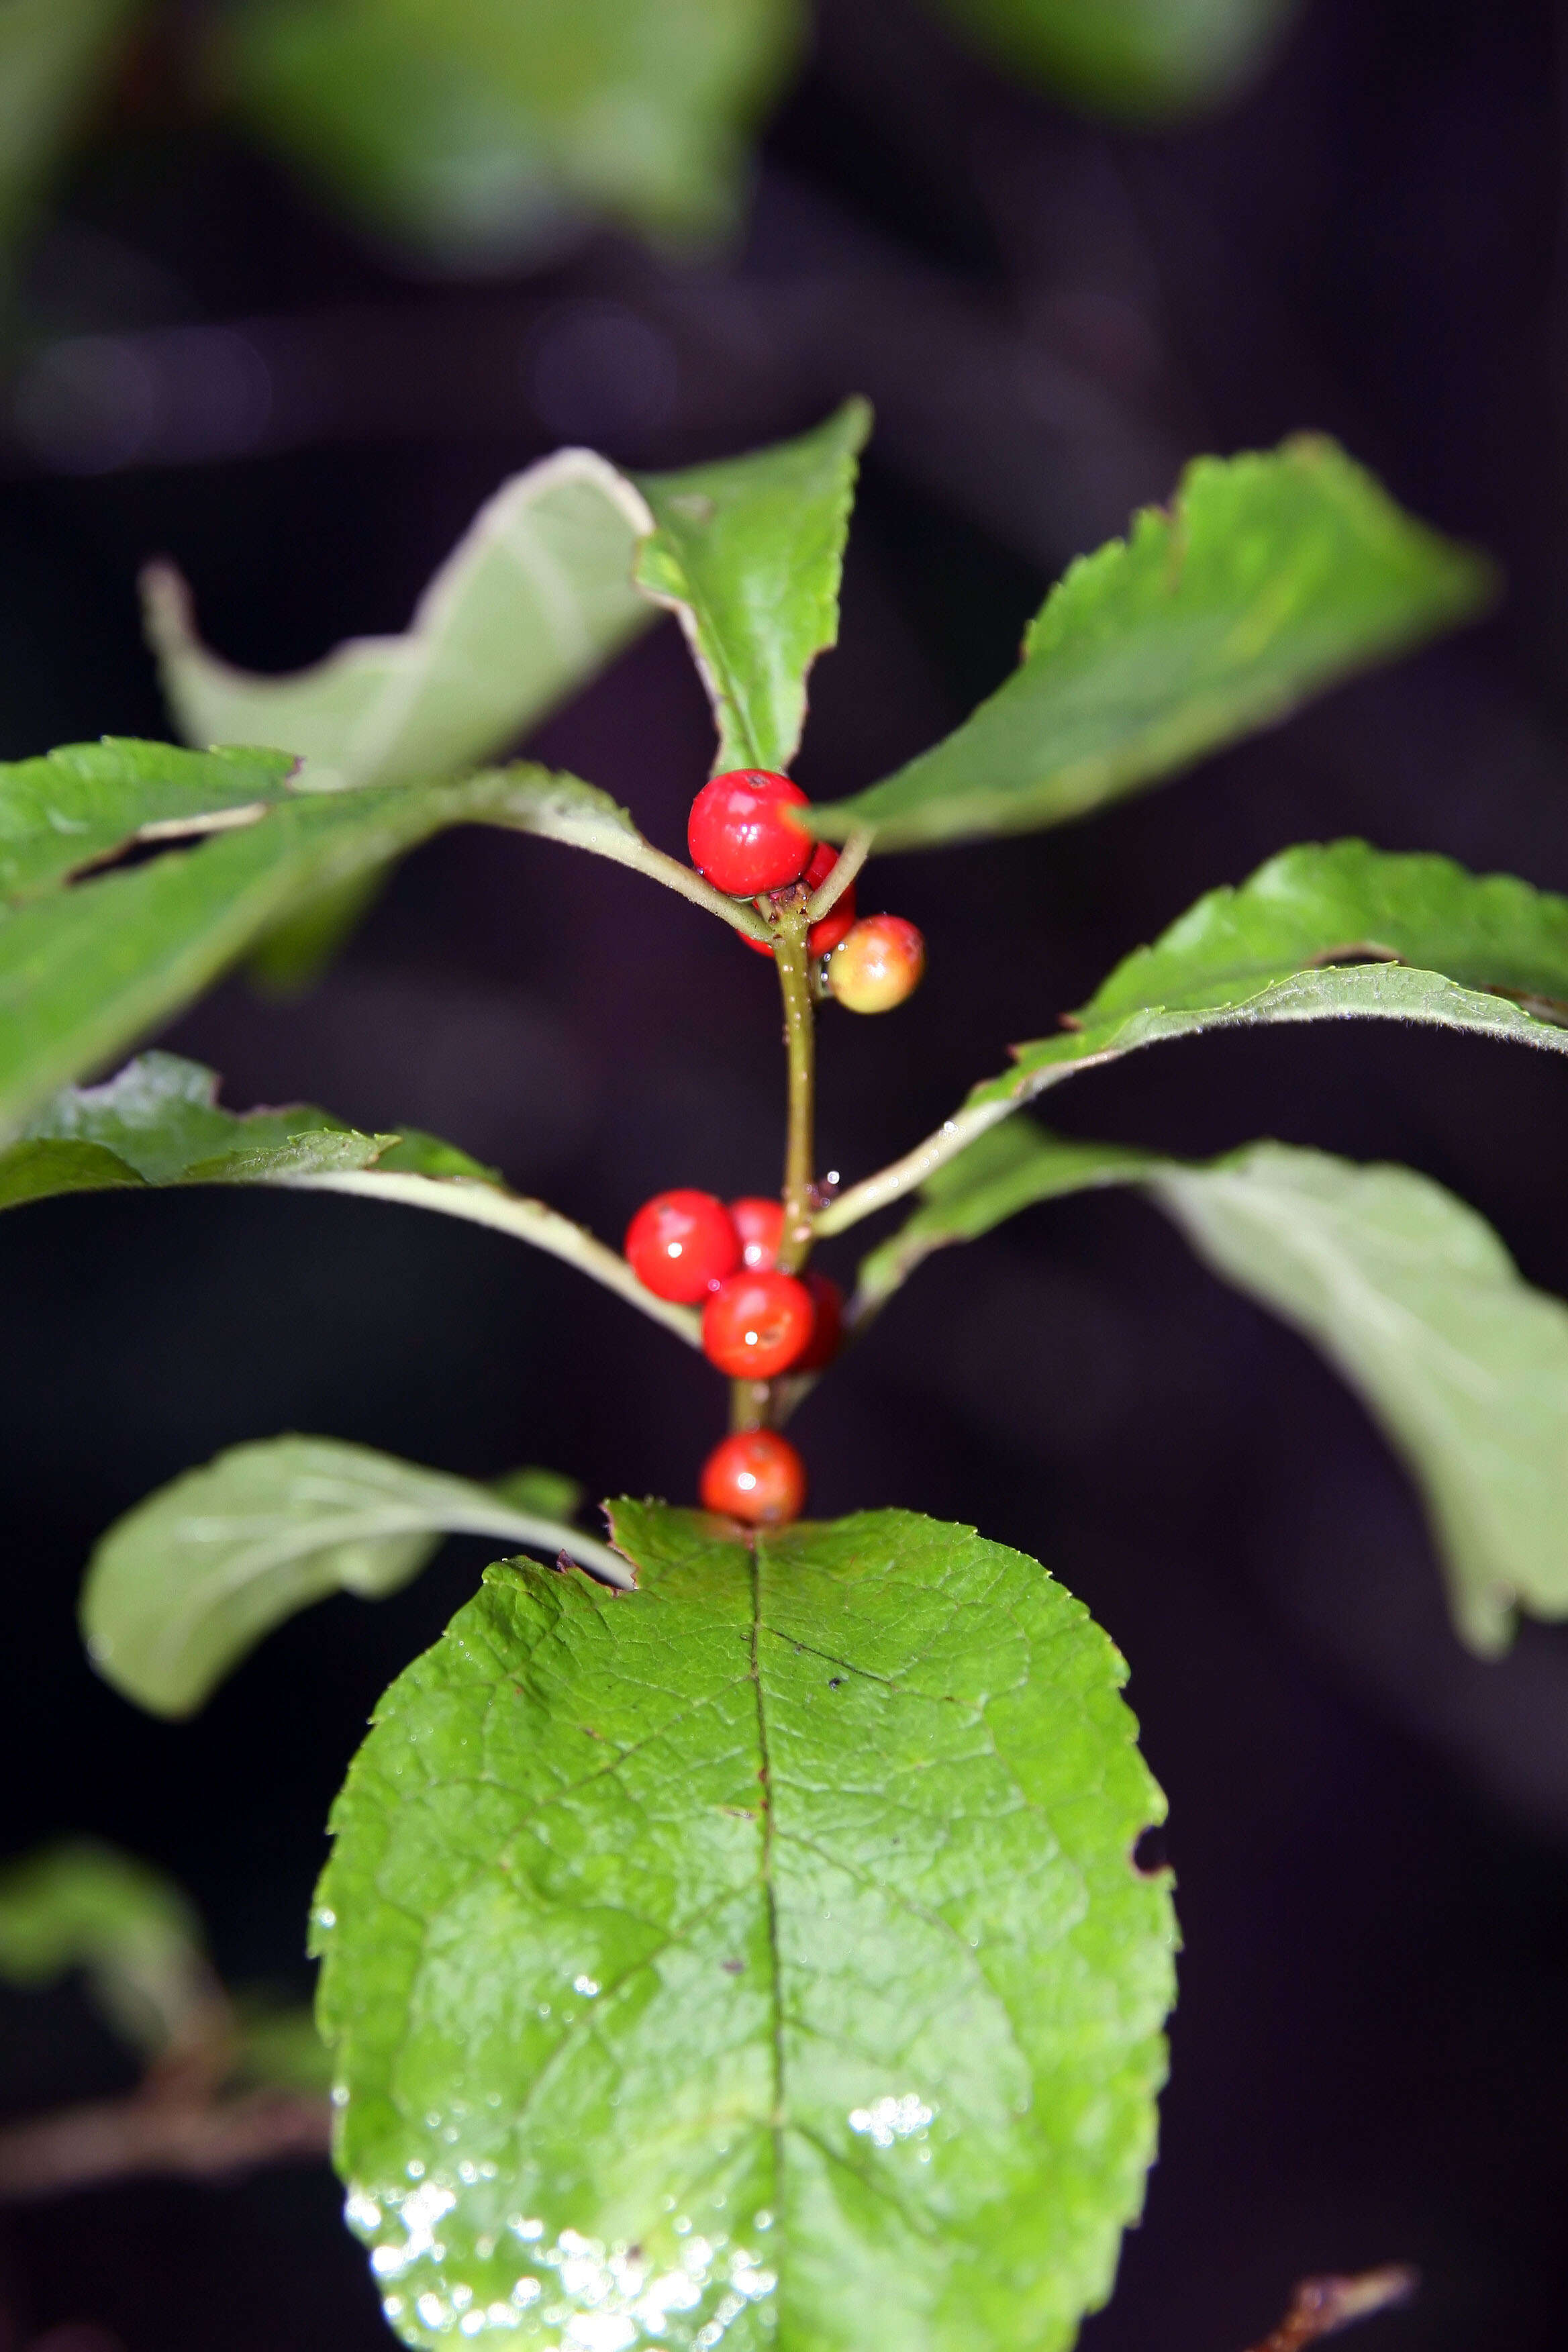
[687,767,926,1014]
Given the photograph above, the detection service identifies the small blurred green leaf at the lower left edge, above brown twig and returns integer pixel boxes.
[0,1839,216,2058]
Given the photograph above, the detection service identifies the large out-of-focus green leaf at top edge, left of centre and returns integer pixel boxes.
[224,0,804,266]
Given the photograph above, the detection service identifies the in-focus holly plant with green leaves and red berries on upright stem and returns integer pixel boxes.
[0,402,1568,2352]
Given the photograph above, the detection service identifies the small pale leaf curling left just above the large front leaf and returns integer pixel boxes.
[83,1437,628,1714]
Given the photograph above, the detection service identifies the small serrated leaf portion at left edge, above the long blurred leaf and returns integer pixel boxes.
[0,736,296,908]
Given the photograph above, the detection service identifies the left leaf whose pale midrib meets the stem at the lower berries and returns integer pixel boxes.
[0,1054,701,1348]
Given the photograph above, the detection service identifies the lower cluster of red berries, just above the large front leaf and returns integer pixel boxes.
[626,1193,844,1524]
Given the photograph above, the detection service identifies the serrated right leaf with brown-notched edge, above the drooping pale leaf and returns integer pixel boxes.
[816,842,1568,1235]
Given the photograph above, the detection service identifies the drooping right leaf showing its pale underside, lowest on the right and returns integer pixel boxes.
[858,1120,1568,1651]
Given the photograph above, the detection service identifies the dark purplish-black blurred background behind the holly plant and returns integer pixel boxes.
[0,0,1568,2352]
